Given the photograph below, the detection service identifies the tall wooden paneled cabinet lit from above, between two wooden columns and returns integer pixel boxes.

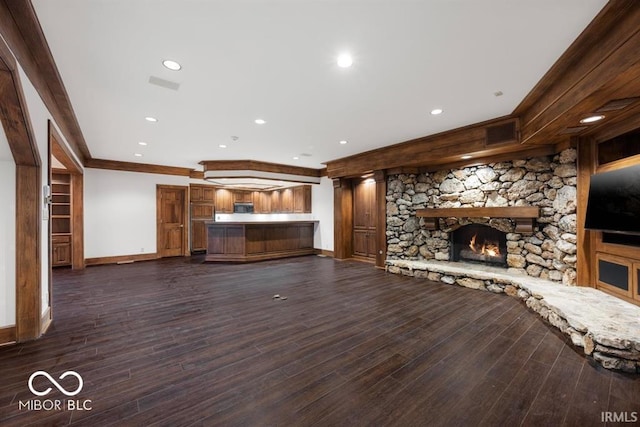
[353,180,377,258]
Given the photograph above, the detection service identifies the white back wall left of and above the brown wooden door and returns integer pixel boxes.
[84,169,189,258]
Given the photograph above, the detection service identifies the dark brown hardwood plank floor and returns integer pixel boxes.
[0,256,640,426]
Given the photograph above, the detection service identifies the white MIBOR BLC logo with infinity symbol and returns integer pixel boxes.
[19,371,91,411]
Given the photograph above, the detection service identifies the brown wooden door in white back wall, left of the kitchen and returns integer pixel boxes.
[156,185,187,258]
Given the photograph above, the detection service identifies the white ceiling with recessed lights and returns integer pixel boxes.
[32,0,606,169]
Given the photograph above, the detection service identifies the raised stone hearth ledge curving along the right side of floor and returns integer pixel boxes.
[386,260,640,373]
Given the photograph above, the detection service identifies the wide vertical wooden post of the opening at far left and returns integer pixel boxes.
[16,165,42,342]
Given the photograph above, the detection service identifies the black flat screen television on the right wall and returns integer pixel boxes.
[585,165,640,235]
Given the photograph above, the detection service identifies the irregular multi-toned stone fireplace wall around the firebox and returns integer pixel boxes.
[386,149,577,285]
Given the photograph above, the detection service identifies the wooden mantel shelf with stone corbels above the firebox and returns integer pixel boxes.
[416,206,540,234]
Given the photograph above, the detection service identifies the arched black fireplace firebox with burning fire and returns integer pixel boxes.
[450,224,507,267]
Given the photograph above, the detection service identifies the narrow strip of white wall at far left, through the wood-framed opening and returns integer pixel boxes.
[0,126,16,328]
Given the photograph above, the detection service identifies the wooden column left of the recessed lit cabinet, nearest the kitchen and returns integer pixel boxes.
[333,178,353,259]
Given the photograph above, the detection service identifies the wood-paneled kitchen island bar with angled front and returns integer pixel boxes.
[205,221,318,262]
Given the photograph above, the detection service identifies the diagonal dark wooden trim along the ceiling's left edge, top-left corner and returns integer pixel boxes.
[0,0,91,162]
